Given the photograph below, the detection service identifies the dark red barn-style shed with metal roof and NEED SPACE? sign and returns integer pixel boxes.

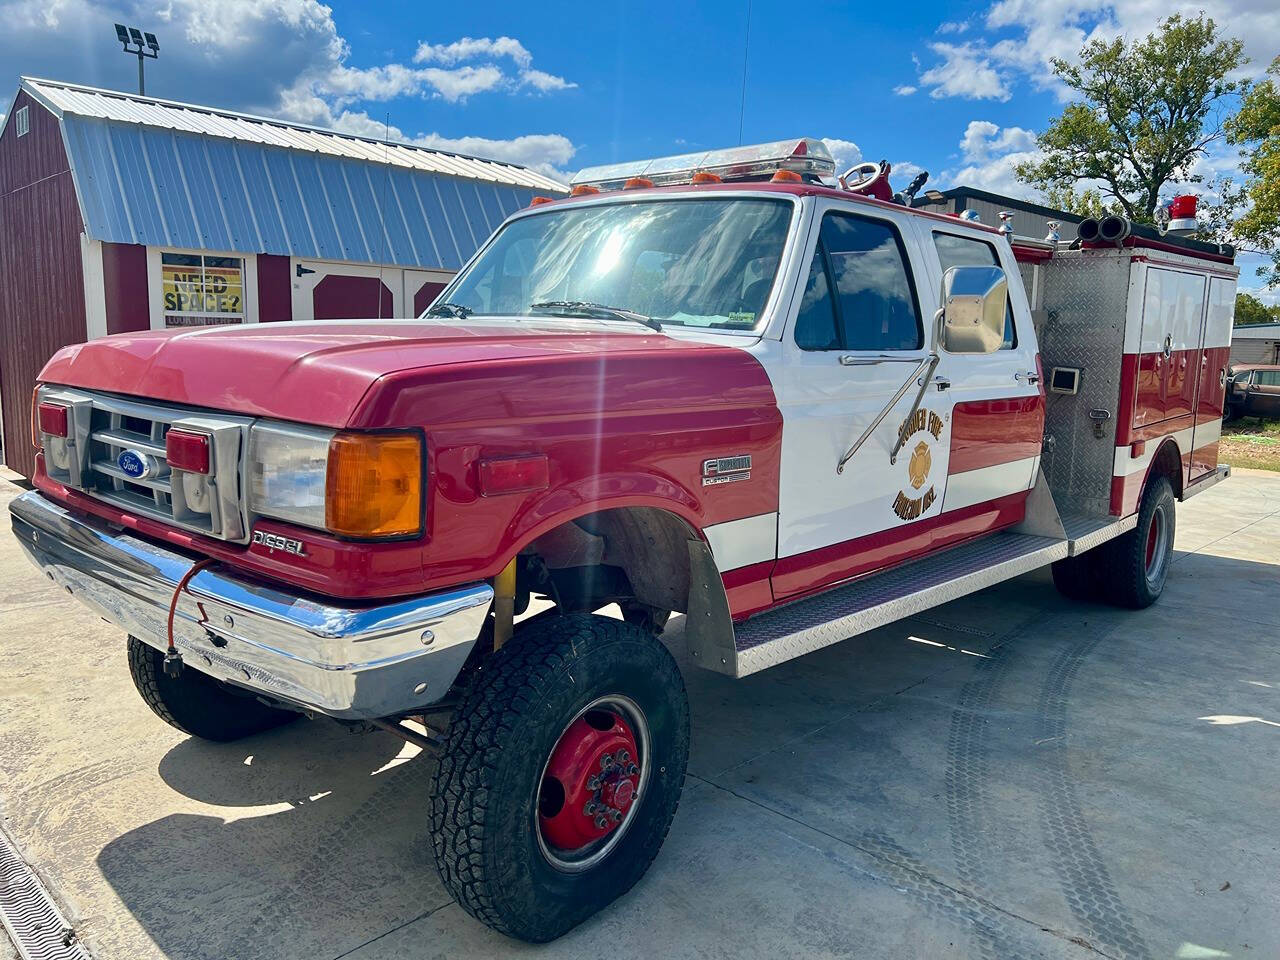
[0,77,567,475]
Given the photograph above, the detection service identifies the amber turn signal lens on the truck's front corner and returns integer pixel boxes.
[325,433,422,536]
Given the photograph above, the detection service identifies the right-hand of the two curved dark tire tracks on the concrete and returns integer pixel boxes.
[1036,625,1149,957]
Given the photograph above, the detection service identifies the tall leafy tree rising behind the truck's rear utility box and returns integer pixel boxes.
[1016,14,1247,223]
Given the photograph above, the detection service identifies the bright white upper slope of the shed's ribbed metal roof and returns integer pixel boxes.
[22,77,567,193]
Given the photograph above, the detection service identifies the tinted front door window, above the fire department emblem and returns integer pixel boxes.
[795,214,924,351]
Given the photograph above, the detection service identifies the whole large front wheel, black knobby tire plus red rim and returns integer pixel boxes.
[430,614,689,942]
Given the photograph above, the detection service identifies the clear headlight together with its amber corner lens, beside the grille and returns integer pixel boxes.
[240,424,422,536]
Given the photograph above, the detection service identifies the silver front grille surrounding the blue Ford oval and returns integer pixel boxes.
[40,387,251,543]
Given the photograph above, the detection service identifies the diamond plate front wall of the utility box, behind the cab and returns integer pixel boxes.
[1039,251,1132,516]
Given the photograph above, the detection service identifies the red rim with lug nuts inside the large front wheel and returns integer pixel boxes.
[535,698,649,870]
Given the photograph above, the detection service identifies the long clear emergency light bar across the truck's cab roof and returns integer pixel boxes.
[570,137,836,189]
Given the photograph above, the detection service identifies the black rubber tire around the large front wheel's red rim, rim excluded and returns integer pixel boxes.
[430,614,689,943]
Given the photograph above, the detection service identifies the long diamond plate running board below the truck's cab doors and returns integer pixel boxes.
[724,532,1069,677]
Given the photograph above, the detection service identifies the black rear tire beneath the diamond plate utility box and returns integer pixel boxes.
[1098,476,1176,611]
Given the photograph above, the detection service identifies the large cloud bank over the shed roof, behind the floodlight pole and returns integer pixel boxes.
[0,0,575,174]
